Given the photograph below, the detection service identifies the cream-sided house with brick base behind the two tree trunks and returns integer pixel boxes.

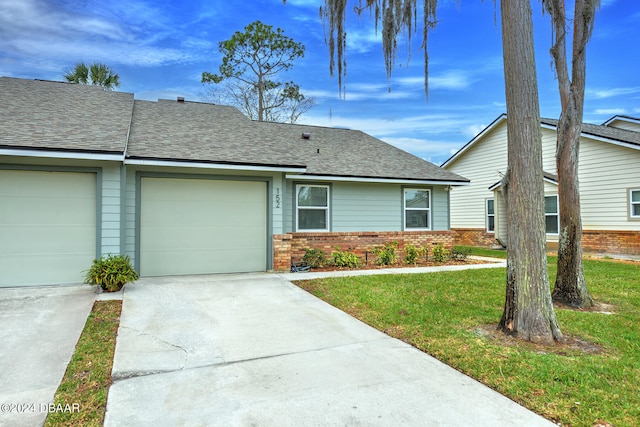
[442,115,640,256]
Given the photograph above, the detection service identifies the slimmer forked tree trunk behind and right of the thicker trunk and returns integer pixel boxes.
[542,0,600,308]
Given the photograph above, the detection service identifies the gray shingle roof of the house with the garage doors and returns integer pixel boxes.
[0,77,468,183]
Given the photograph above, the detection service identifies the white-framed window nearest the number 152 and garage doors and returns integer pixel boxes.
[296,185,329,231]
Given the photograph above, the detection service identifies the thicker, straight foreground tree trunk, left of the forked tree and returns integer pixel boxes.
[499,0,562,342]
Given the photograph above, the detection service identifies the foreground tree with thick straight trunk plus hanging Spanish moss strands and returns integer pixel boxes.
[312,0,562,342]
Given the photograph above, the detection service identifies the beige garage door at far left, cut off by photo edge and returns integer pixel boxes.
[0,170,96,286]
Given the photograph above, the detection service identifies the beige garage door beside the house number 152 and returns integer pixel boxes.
[140,177,267,276]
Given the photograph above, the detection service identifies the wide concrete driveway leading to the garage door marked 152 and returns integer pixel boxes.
[105,274,553,427]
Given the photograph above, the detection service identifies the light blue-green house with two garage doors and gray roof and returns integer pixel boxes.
[0,77,468,286]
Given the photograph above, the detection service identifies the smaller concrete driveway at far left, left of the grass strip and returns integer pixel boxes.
[0,285,96,427]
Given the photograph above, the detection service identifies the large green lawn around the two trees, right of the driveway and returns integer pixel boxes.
[297,257,640,427]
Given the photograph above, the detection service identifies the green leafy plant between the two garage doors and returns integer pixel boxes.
[84,254,138,292]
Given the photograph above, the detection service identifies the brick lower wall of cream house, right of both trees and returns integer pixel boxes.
[582,230,640,256]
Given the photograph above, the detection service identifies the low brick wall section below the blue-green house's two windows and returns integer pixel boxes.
[273,231,455,271]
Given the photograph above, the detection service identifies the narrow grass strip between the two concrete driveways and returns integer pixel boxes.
[45,301,122,426]
